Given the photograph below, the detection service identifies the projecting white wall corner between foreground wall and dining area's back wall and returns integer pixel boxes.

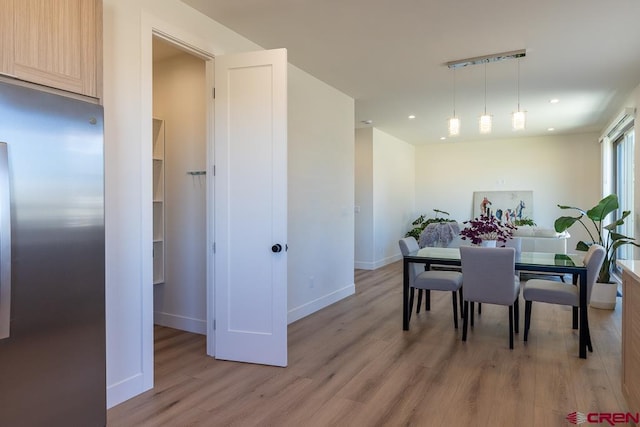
[355,128,415,269]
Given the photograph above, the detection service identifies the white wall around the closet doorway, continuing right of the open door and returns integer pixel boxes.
[103,0,354,407]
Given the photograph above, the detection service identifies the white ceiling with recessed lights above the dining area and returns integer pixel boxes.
[183,0,640,145]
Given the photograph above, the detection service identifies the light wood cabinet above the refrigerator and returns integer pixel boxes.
[0,0,102,98]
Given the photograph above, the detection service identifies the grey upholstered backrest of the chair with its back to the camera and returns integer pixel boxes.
[460,246,516,305]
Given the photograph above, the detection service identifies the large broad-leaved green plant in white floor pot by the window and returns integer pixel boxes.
[554,194,640,309]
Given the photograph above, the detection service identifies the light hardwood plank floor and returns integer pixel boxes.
[108,262,627,427]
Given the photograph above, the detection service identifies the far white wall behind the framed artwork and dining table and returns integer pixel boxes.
[412,134,601,250]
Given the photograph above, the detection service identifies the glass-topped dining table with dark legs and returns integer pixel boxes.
[402,247,592,359]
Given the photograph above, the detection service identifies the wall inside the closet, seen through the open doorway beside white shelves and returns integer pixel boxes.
[153,54,207,334]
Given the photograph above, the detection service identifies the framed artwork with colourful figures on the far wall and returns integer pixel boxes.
[473,191,533,223]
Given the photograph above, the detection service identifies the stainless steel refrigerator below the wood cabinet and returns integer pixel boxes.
[0,78,106,427]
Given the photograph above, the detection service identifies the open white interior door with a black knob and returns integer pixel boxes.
[214,49,287,366]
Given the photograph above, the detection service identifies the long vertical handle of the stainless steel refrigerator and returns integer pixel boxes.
[0,142,11,339]
